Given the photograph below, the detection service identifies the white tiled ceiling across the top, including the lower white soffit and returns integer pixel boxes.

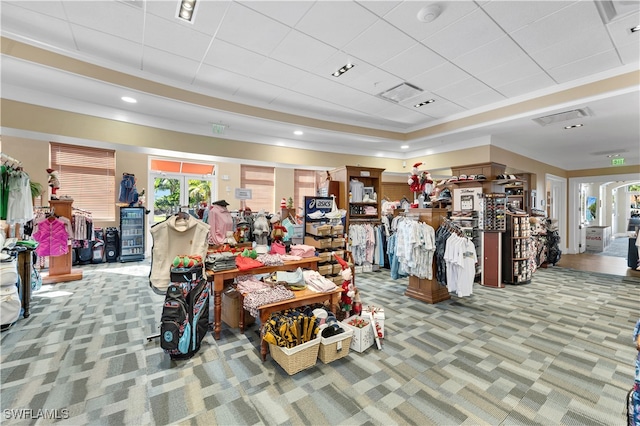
[0,0,640,170]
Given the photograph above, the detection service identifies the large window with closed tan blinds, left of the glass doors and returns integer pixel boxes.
[49,142,116,221]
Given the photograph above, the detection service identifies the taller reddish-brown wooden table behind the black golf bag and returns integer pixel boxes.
[207,257,326,340]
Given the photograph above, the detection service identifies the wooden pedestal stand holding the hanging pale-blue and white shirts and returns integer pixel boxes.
[404,209,451,304]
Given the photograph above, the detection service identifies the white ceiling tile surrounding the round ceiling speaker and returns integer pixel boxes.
[382,0,478,42]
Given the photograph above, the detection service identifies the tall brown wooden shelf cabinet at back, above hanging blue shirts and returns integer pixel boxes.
[329,166,384,232]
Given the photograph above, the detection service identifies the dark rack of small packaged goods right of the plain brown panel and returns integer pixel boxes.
[502,212,531,284]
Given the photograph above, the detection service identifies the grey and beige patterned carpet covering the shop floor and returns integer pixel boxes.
[0,263,640,425]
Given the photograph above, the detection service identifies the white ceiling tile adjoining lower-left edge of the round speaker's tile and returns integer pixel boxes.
[343,21,416,64]
